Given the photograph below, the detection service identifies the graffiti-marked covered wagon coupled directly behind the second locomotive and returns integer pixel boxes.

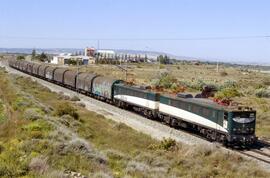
[92,76,122,100]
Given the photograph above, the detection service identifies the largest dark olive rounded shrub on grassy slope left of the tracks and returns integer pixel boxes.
[55,103,79,119]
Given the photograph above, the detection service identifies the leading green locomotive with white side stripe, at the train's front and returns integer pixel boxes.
[159,96,257,145]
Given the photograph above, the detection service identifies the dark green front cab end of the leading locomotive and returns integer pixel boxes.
[227,109,257,145]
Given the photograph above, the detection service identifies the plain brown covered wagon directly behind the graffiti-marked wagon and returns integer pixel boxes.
[76,73,98,93]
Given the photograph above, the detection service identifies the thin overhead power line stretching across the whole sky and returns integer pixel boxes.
[0,35,270,41]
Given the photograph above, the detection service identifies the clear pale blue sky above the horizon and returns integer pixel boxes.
[0,0,270,63]
